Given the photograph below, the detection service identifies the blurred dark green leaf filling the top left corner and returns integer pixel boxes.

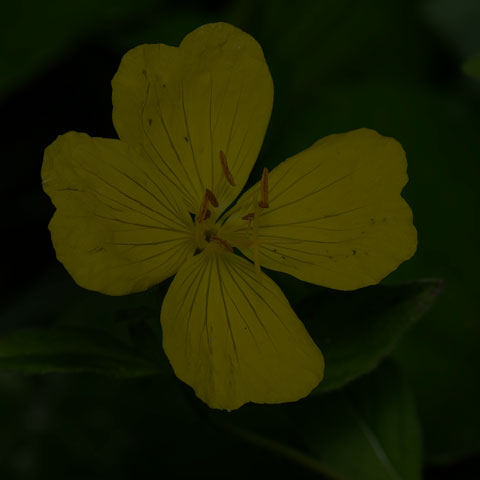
[0,0,158,99]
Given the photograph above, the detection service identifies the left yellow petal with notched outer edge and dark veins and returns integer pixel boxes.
[42,132,195,295]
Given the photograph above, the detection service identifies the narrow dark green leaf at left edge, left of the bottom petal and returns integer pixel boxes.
[0,328,167,377]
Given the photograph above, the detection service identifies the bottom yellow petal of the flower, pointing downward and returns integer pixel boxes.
[161,249,324,410]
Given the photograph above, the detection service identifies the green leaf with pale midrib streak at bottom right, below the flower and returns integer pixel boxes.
[292,364,421,480]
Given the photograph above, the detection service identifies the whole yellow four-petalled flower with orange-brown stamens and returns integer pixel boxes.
[42,23,416,409]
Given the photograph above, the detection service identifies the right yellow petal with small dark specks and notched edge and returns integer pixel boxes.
[218,129,417,290]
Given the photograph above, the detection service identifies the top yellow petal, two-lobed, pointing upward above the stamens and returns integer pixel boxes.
[112,23,273,213]
